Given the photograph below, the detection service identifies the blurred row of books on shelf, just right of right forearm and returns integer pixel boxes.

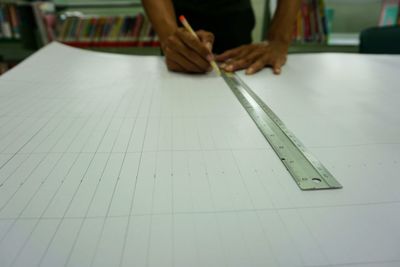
[293,0,328,43]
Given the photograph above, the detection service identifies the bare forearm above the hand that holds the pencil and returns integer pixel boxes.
[142,0,178,43]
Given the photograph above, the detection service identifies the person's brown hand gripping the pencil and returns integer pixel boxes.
[162,28,214,73]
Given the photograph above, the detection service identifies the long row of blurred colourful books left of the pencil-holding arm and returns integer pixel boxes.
[33,2,159,47]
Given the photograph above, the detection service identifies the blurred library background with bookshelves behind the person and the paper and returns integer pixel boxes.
[0,0,400,75]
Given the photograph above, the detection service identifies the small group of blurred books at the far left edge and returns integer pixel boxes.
[0,3,21,39]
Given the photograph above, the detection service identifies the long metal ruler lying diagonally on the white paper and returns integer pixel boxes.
[222,72,342,190]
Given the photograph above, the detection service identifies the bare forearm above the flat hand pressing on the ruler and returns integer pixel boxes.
[267,0,301,45]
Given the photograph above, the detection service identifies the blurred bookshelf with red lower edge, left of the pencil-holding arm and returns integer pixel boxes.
[34,1,160,55]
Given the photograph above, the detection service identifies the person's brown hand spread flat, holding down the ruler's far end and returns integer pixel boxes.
[216,41,289,74]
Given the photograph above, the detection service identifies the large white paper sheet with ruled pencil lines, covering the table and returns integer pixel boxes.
[0,43,400,267]
